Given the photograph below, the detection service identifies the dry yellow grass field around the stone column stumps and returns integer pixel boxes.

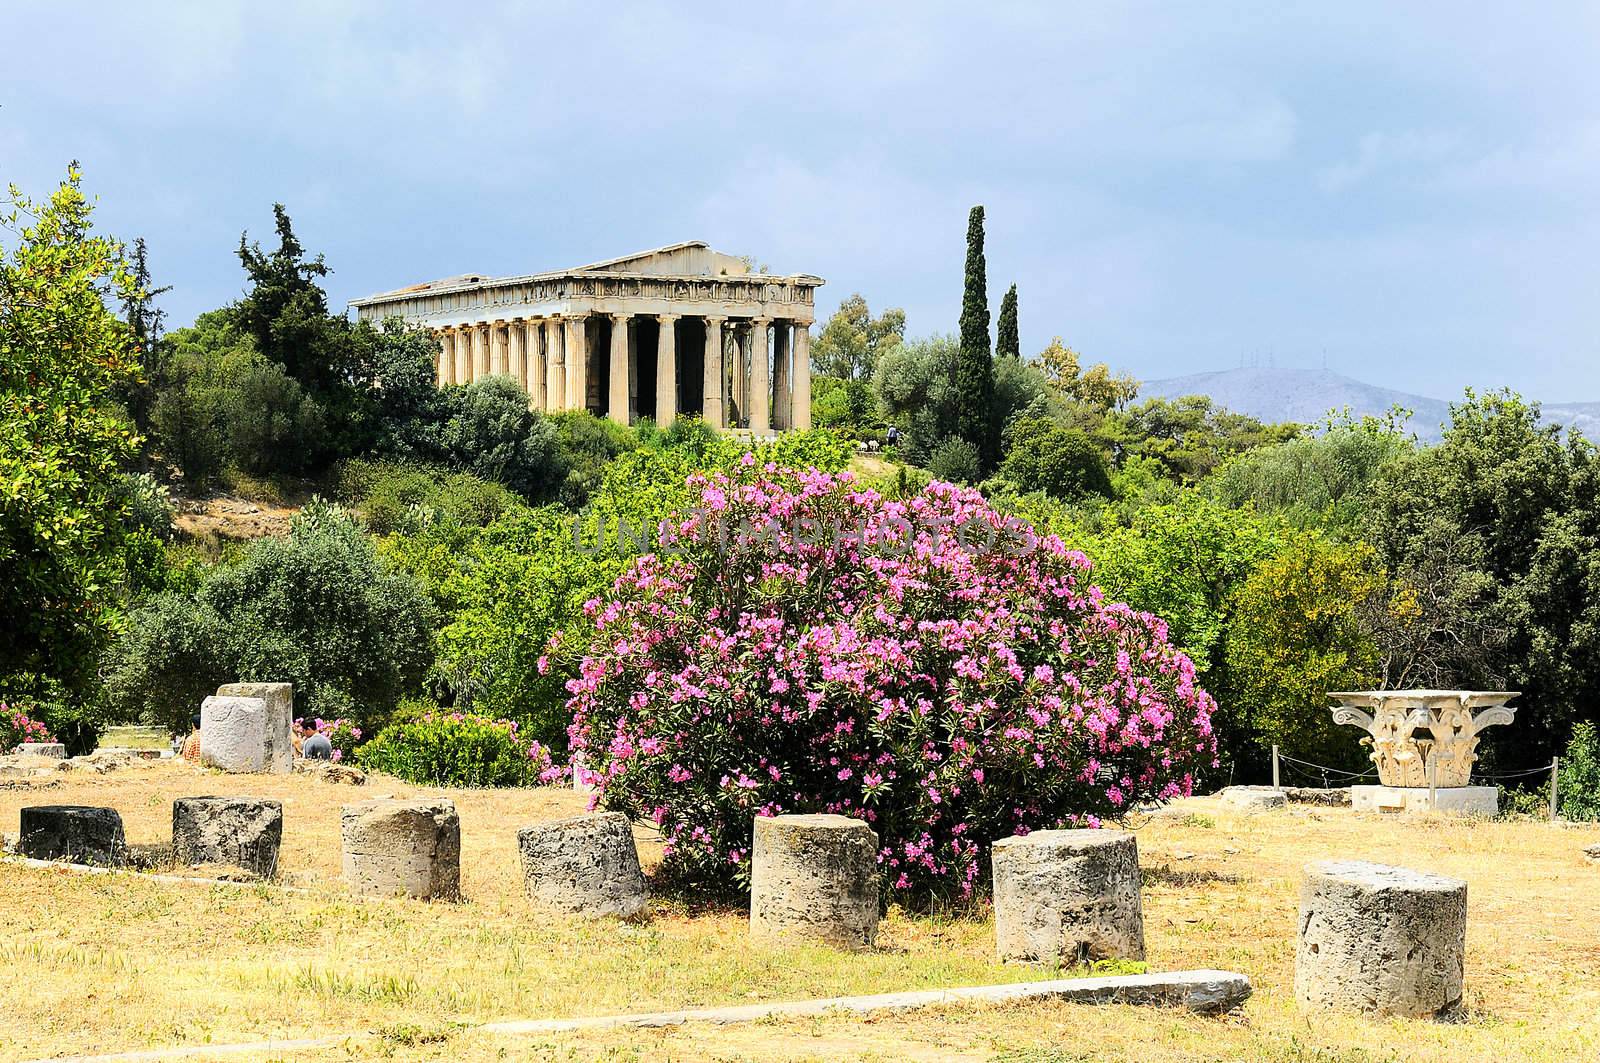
[0,762,1600,1063]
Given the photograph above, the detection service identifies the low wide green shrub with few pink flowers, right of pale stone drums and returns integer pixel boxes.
[355,712,560,786]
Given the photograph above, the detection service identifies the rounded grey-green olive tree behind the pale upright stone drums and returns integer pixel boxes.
[106,499,434,730]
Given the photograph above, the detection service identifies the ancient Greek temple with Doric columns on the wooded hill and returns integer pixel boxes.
[350,240,822,435]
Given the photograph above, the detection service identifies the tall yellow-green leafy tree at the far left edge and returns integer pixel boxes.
[0,168,138,687]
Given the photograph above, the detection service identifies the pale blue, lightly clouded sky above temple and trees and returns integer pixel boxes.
[0,0,1600,400]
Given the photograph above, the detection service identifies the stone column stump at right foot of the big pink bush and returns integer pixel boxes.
[992,831,1144,967]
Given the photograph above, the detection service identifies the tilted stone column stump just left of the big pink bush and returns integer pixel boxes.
[517,812,645,919]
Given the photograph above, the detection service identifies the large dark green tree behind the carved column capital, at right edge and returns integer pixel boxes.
[1365,392,1600,768]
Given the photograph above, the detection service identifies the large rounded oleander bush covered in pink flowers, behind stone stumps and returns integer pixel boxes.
[547,459,1216,898]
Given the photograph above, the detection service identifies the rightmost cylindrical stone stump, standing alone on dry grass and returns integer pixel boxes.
[1294,860,1467,1017]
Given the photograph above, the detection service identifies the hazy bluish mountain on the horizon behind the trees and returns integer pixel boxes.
[1139,368,1600,443]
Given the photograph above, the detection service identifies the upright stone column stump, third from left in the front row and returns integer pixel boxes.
[339,797,461,900]
